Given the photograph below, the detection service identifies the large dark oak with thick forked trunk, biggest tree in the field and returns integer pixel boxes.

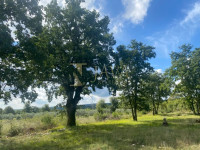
[25,0,115,126]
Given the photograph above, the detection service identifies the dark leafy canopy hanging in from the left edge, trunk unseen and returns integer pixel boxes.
[0,0,42,103]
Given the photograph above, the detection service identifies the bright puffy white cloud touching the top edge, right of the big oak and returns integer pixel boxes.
[122,0,151,24]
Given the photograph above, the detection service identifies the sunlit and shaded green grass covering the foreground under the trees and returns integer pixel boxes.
[0,114,200,150]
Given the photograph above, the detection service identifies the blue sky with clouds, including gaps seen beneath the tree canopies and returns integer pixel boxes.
[0,0,200,108]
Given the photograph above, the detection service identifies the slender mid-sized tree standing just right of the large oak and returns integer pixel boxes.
[117,40,156,121]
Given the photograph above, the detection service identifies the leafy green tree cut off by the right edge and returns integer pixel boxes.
[169,45,200,114]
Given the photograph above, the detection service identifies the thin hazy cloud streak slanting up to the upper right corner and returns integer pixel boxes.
[146,2,200,58]
